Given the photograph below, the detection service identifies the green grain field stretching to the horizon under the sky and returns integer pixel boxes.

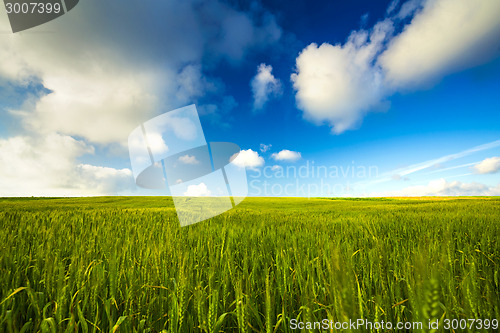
[0,197,500,332]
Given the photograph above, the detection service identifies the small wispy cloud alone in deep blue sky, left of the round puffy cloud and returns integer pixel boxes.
[250,64,282,110]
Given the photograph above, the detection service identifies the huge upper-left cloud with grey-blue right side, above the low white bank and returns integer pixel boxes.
[0,0,281,145]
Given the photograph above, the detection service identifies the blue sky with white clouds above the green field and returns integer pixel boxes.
[0,0,500,197]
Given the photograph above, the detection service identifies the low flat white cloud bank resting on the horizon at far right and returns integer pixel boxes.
[377,178,500,197]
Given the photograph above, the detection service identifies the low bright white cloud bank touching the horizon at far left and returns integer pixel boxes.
[0,134,134,196]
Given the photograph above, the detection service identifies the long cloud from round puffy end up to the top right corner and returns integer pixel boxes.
[291,0,500,134]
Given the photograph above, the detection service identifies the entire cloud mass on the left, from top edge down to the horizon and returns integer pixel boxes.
[0,0,282,195]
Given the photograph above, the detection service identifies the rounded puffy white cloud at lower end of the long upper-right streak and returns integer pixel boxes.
[291,20,393,134]
